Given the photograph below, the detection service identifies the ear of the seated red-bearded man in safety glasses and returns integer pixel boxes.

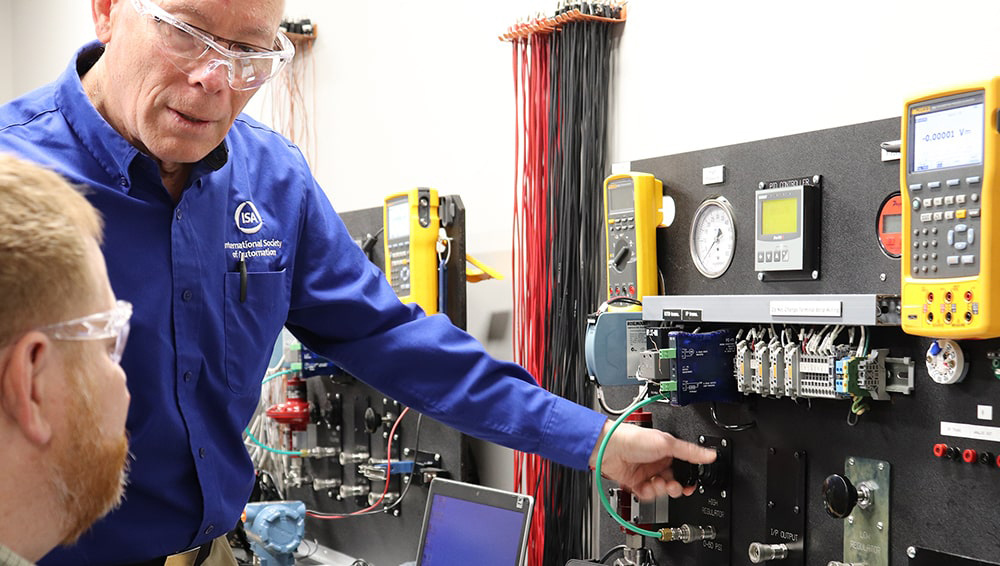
[0,330,58,446]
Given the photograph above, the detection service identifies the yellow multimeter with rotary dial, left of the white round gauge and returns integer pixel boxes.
[604,173,663,310]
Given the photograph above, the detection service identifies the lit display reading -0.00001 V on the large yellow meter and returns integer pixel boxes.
[910,102,984,172]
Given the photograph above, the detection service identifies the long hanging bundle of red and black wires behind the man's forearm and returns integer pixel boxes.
[513,14,611,565]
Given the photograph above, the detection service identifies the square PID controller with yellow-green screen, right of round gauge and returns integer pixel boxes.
[754,175,822,280]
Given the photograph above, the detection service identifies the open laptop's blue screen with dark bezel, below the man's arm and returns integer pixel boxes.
[417,479,532,566]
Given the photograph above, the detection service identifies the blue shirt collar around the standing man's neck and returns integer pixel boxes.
[55,41,229,192]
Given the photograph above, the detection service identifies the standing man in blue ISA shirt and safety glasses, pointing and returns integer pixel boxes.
[0,0,715,565]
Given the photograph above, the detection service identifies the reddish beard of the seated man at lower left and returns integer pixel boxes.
[48,364,128,545]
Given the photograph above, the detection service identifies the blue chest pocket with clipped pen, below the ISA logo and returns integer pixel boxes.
[225,269,288,395]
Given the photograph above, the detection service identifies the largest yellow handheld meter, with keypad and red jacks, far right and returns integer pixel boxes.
[899,77,1000,338]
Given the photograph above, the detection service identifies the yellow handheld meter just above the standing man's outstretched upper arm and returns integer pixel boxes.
[382,188,441,314]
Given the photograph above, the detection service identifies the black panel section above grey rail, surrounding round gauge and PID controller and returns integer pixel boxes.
[632,118,900,295]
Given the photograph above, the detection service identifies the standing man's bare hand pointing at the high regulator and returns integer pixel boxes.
[590,421,716,501]
